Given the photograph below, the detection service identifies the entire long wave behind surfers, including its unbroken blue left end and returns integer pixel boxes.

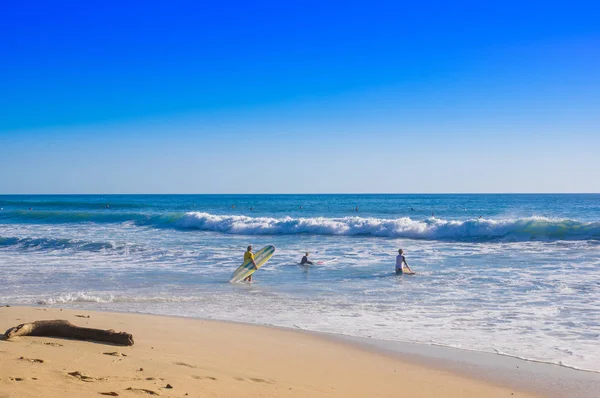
[0,211,600,243]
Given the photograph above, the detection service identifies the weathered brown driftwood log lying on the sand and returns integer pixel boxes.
[4,320,133,345]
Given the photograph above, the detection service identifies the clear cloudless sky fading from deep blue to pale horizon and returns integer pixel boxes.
[0,0,600,193]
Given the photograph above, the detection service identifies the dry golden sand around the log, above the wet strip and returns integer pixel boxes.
[0,307,533,398]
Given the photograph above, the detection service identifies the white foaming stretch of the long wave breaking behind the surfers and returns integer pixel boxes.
[176,212,600,241]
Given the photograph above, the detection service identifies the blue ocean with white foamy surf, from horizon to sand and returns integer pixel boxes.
[0,194,600,372]
